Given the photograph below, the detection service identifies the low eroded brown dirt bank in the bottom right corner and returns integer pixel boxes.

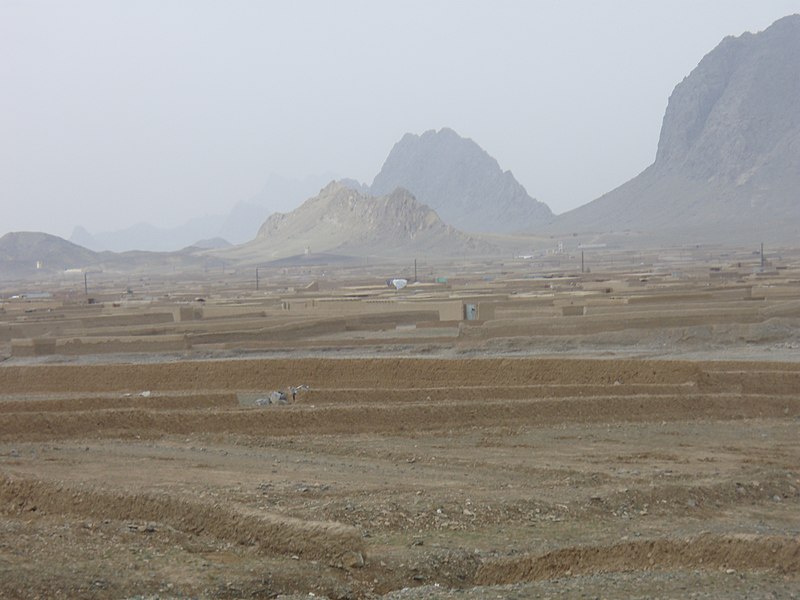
[476,535,800,585]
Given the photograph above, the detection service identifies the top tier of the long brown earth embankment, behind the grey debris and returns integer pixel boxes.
[0,358,701,394]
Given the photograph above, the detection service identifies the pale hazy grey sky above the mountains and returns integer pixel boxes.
[0,0,800,237]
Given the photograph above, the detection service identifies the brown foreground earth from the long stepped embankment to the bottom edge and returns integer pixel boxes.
[0,358,800,598]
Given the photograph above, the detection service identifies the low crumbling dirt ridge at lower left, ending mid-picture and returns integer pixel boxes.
[0,477,365,566]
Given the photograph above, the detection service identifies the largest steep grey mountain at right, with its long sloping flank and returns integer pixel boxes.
[551,15,800,243]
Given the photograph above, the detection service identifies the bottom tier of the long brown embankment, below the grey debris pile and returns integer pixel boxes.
[0,395,800,440]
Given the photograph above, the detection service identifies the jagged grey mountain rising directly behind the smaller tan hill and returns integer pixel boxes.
[370,128,553,233]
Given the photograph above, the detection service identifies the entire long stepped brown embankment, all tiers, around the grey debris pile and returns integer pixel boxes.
[0,359,800,440]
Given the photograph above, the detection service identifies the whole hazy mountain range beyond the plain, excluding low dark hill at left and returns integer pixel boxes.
[10,15,800,266]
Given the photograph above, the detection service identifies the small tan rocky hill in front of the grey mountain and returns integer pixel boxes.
[225,182,499,260]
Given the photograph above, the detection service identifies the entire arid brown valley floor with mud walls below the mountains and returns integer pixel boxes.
[0,248,800,599]
